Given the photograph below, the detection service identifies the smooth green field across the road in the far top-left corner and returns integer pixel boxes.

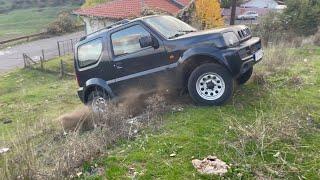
[0,5,77,40]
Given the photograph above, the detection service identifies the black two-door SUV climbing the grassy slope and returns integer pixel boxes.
[75,16,263,111]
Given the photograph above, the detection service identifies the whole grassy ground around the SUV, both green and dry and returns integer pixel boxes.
[0,46,320,179]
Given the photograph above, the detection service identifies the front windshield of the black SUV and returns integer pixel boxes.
[144,16,196,39]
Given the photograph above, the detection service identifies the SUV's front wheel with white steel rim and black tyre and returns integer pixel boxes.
[188,64,234,106]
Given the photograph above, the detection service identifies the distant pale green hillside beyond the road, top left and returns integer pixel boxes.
[0,0,81,41]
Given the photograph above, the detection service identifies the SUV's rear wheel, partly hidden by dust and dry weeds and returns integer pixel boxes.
[87,89,110,113]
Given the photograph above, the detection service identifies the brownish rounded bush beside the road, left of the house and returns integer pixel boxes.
[47,12,76,35]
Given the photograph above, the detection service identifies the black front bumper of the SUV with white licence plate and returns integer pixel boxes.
[225,38,263,78]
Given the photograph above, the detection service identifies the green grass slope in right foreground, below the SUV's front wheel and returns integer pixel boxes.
[85,48,320,179]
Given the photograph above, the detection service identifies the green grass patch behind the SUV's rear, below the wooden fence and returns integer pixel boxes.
[0,57,80,146]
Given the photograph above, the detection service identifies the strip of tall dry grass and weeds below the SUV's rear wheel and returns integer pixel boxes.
[0,94,167,179]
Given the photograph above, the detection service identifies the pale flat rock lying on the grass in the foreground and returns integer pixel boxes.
[192,156,230,176]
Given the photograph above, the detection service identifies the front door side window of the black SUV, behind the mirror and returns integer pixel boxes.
[111,25,150,56]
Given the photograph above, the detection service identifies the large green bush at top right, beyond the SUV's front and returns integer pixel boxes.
[253,0,320,46]
